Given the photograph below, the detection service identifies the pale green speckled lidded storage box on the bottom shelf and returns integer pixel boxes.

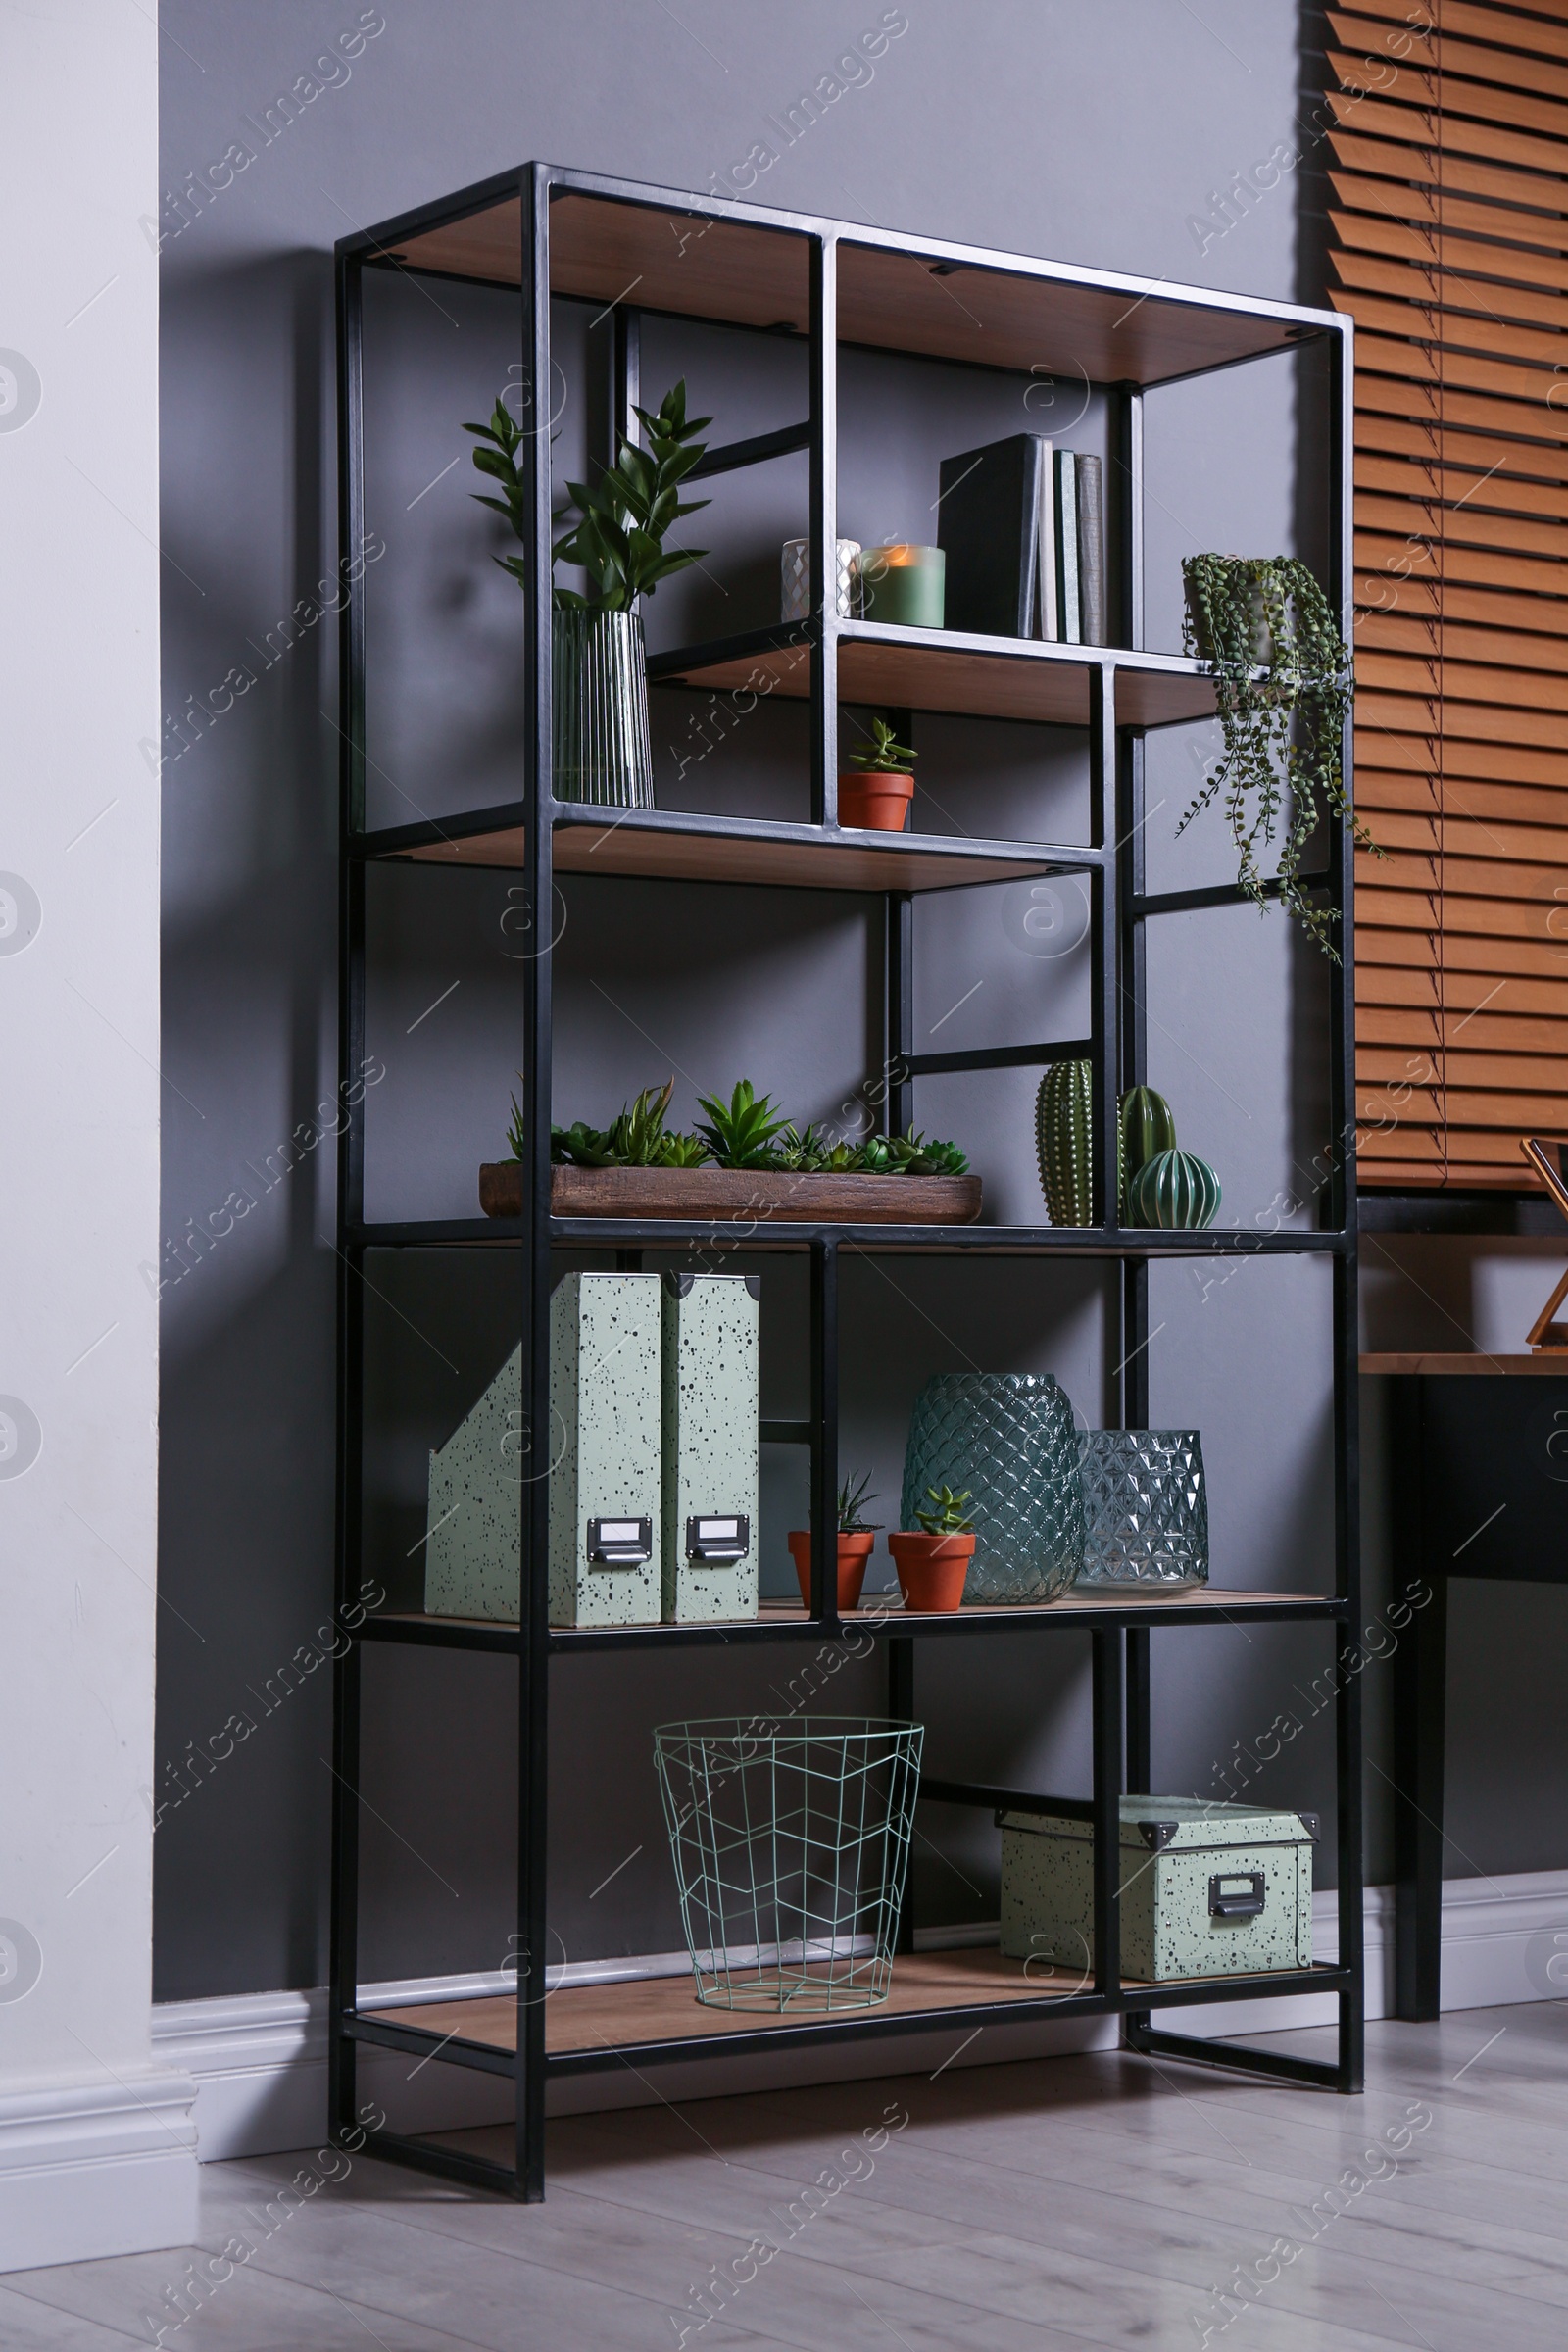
[1002,1797,1316,1983]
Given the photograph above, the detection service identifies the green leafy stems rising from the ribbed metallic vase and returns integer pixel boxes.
[464,376,712,612]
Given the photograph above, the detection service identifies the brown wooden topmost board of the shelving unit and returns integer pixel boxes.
[383,190,1314,386]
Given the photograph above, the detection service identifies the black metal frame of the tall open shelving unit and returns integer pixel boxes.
[329,163,1363,2201]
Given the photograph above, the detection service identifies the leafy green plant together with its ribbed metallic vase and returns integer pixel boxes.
[464,378,712,809]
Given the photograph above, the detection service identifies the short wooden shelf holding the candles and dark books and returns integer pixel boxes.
[649,621,1215,727]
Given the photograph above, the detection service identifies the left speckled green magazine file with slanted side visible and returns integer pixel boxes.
[425,1275,659,1625]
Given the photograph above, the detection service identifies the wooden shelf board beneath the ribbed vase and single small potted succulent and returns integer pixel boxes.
[387,805,1096,892]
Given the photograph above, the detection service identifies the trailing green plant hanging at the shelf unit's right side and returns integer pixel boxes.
[1175,555,1382,964]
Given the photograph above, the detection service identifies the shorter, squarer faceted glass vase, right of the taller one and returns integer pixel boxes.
[1079,1430,1208,1586]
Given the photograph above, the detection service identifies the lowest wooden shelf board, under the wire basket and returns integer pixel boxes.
[369,1947,1335,2051]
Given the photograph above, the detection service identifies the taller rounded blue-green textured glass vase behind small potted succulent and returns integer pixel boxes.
[898,1371,1084,1609]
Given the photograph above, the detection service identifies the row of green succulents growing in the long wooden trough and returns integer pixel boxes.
[506,1077,968,1176]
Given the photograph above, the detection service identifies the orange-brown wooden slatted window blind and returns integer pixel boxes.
[1328,0,1568,1188]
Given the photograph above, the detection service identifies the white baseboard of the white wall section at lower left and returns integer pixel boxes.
[0,2079,201,2272]
